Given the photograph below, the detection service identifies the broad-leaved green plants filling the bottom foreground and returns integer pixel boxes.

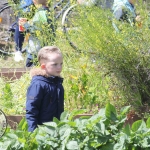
[0,103,150,150]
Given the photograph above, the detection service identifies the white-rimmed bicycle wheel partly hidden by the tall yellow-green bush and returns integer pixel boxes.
[62,4,82,51]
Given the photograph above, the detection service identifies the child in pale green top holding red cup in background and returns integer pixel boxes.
[19,0,55,67]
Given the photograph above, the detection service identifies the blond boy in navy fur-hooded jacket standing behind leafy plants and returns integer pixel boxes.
[26,46,64,132]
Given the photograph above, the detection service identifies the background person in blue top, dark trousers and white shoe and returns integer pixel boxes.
[14,0,33,62]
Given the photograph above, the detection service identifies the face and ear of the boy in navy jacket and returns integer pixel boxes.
[41,53,63,76]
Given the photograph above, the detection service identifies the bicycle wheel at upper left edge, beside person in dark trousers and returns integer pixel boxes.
[0,3,16,55]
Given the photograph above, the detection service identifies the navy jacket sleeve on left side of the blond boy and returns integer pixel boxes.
[26,83,44,132]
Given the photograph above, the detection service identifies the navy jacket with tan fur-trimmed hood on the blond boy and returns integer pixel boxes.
[26,69,64,132]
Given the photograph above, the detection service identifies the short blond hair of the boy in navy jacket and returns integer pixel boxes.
[38,46,62,64]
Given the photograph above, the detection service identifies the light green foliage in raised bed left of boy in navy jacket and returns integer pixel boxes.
[0,73,31,115]
